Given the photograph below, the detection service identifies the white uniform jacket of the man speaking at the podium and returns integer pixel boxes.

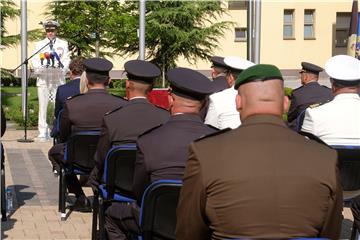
[31,38,70,86]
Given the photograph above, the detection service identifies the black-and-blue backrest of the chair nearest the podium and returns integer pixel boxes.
[64,129,100,172]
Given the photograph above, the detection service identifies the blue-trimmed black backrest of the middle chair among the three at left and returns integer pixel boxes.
[103,143,136,200]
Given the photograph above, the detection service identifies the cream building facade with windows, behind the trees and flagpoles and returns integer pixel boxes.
[0,0,352,84]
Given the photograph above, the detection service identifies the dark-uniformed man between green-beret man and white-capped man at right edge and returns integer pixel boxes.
[288,62,334,131]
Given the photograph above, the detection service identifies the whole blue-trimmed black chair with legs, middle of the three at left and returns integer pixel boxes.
[92,143,136,239]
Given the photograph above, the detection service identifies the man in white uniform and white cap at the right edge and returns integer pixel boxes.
[301,55,360,145]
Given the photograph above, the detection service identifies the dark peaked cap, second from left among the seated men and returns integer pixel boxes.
[124,60,161,84]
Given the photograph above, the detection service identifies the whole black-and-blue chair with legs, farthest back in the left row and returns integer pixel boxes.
[59,129,100,221]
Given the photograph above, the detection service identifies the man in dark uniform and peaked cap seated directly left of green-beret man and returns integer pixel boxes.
[105,68,217,239]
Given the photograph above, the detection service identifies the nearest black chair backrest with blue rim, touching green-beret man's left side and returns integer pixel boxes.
[140,180,182,240]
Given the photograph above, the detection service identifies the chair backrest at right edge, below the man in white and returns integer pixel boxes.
[331,146,360,191]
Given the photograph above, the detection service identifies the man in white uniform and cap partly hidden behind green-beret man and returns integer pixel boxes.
[205,56,254,129]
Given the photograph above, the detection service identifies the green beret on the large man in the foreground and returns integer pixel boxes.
[234,64,284,89]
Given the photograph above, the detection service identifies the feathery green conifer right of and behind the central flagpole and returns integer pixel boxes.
[111,0,232,75]
